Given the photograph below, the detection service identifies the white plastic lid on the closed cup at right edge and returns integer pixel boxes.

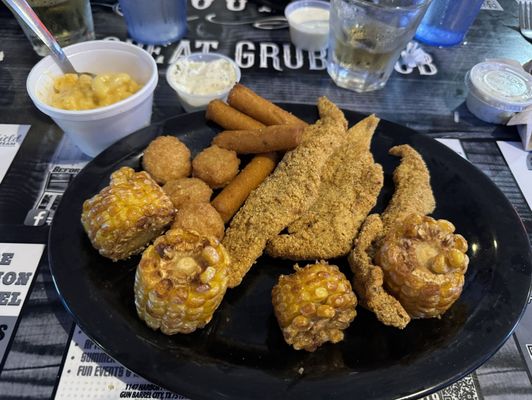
[466,60,532,112]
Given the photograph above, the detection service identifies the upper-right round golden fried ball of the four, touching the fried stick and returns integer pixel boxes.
[192,145,240,189]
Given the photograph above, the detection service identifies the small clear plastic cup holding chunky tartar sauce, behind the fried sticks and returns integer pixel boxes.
[166,53,240,112]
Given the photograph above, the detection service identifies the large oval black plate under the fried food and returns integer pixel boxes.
[49,104,532,399]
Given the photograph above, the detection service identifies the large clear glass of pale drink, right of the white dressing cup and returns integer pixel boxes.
[327,0,430,92]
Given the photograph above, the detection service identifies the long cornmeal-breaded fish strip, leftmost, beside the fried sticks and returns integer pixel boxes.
[222,97,347,287]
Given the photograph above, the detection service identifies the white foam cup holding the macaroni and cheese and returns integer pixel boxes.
[26,40,158,157]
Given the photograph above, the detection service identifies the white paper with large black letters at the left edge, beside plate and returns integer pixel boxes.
[0,243,44,371]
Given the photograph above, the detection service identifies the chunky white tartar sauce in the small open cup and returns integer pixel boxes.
[173,59,237,96]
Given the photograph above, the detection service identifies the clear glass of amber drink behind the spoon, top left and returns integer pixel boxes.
[17,0,94,56]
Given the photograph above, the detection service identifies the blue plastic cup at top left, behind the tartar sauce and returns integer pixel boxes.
[120,0,187,44]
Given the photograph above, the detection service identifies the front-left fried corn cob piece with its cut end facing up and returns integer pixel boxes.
[134,229,229,335]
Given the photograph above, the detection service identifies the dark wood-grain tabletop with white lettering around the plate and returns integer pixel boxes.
[0,0,532,399]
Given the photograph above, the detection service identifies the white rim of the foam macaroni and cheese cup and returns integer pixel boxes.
[26,40,159,120]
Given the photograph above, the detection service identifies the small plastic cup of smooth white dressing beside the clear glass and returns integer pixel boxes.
[284,0,331,51]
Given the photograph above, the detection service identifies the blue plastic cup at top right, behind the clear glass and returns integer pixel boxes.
[415,0,484,46]
